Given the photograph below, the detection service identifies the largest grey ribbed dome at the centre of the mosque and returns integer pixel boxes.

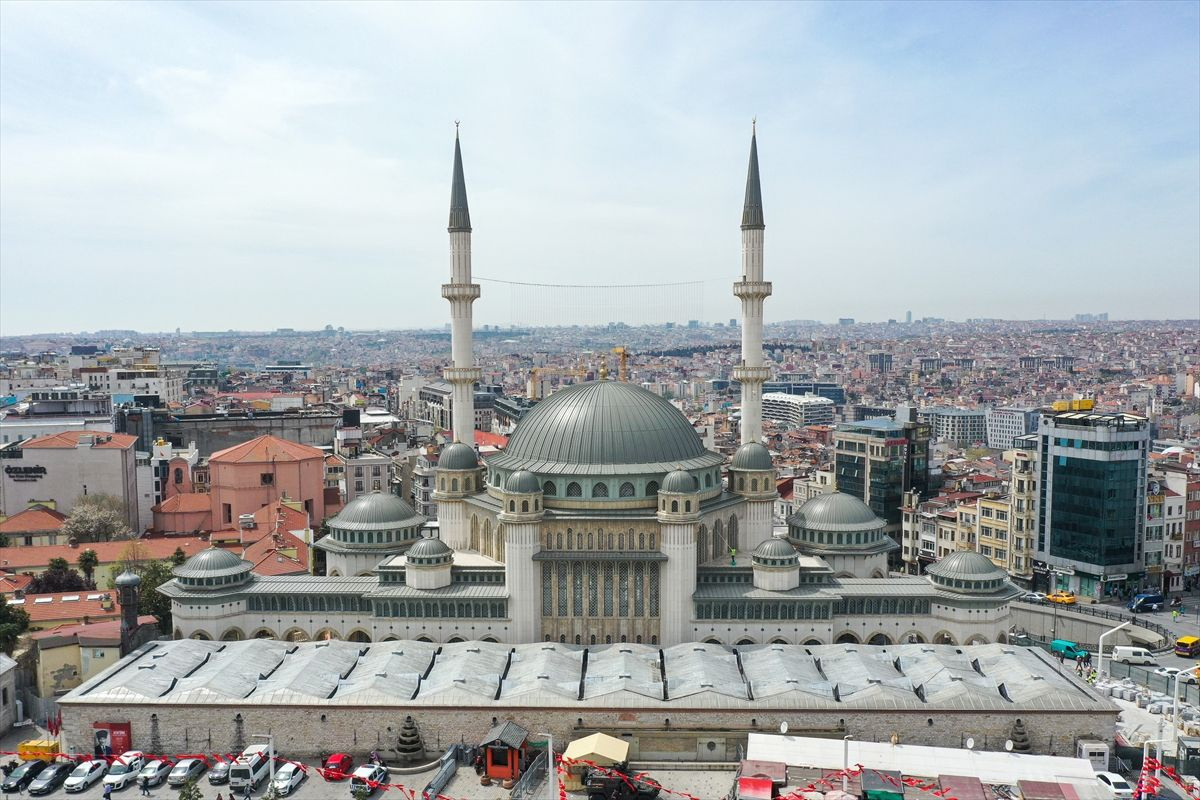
[487,380,722,475]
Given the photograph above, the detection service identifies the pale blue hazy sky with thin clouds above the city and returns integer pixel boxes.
[0,0,1200,335]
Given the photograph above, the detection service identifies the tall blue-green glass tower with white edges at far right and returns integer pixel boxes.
[1034,410,1150,599]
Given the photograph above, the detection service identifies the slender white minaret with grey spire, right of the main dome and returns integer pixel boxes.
[733,128,770,444]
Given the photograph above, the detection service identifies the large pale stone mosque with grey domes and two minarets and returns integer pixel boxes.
[160,128,1020,646]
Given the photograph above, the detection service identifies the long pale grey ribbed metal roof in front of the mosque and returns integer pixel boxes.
[60,639,1117,715]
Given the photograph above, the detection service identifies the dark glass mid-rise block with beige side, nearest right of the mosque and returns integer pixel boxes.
[833,419,929,541]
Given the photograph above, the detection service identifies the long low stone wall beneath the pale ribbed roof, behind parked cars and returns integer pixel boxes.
[61,702,1118,760]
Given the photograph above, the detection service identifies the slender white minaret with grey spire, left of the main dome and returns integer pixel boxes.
[442,128,482,447]
